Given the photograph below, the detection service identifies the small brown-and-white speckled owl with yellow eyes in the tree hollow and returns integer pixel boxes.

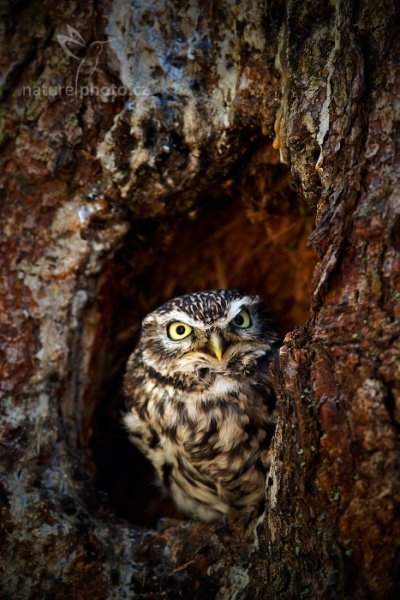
[124,290,279,521]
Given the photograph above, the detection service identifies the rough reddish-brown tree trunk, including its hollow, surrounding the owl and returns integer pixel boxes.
[0,0,400,599]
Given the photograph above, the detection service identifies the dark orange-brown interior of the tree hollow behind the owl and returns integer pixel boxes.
[91,146,316,527]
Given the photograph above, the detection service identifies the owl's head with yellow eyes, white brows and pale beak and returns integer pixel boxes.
[141,290,278,374]
